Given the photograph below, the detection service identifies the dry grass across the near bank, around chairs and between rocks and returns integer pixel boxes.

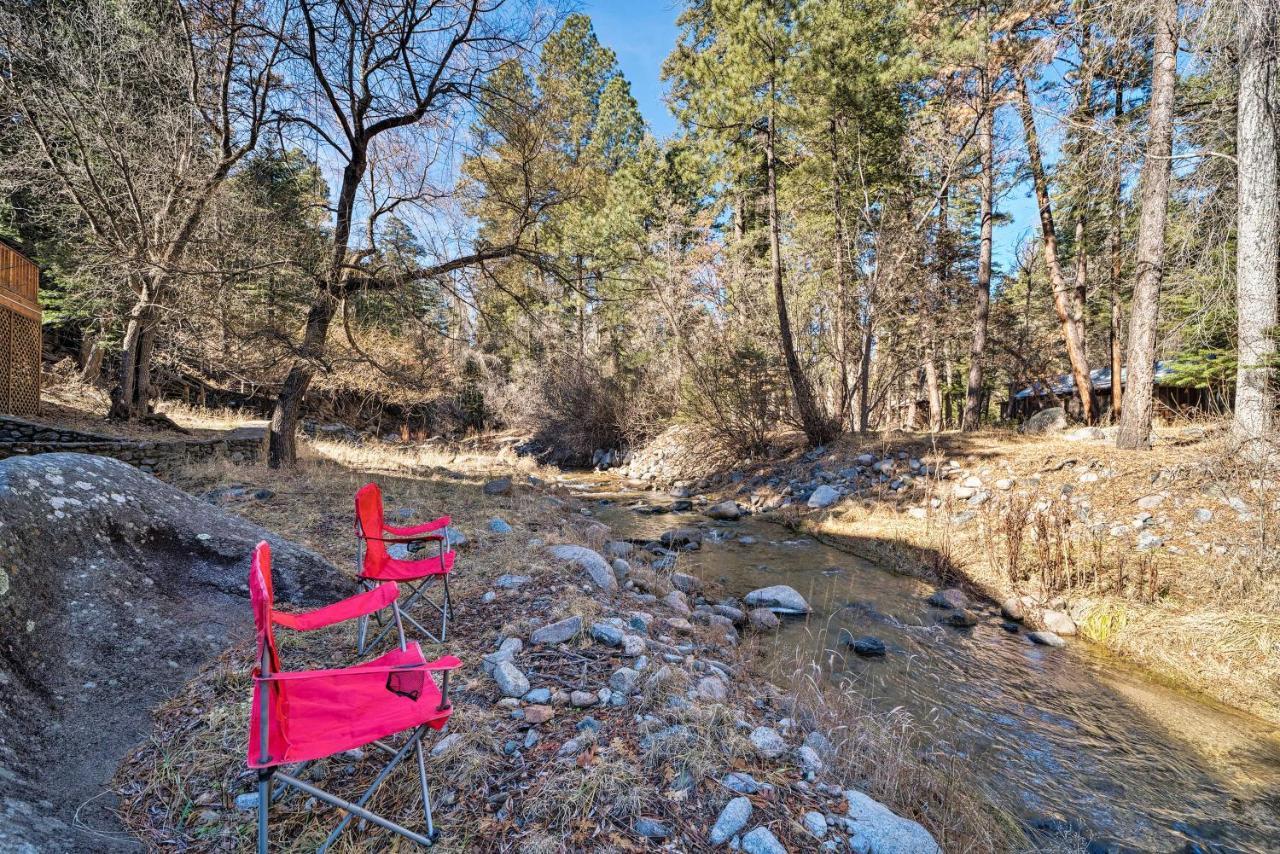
[102,412,1016,853]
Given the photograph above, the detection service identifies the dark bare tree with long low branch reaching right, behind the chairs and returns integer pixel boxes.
[269,0,547,466]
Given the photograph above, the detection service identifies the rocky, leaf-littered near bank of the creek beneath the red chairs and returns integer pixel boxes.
[112,450,977,853]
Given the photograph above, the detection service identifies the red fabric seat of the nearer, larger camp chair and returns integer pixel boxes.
[248,643,453,768]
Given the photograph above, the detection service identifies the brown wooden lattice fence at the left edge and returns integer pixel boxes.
[0,243,40,415]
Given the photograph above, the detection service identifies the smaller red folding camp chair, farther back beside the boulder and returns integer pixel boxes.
[356,484,456,654]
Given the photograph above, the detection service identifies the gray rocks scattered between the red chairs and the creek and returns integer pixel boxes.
[476,530,940,854]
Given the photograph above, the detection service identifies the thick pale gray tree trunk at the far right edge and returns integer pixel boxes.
[1231,0,1280,457]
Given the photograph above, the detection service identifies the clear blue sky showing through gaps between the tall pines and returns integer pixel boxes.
[582,0,1034,273]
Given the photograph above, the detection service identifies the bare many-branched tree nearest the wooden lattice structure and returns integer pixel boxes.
[0,0,279,419]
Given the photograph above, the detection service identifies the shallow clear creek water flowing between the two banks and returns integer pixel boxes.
[564,475,1280,854]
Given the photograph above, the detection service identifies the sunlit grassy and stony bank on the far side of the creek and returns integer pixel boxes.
[617,425,1280,723]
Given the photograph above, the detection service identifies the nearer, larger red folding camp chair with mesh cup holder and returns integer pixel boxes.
[248,543,462,854]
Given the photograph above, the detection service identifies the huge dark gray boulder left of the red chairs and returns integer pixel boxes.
[0,453,355,851]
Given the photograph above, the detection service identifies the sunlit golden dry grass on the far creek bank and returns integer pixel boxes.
[773,431,1280,722]
